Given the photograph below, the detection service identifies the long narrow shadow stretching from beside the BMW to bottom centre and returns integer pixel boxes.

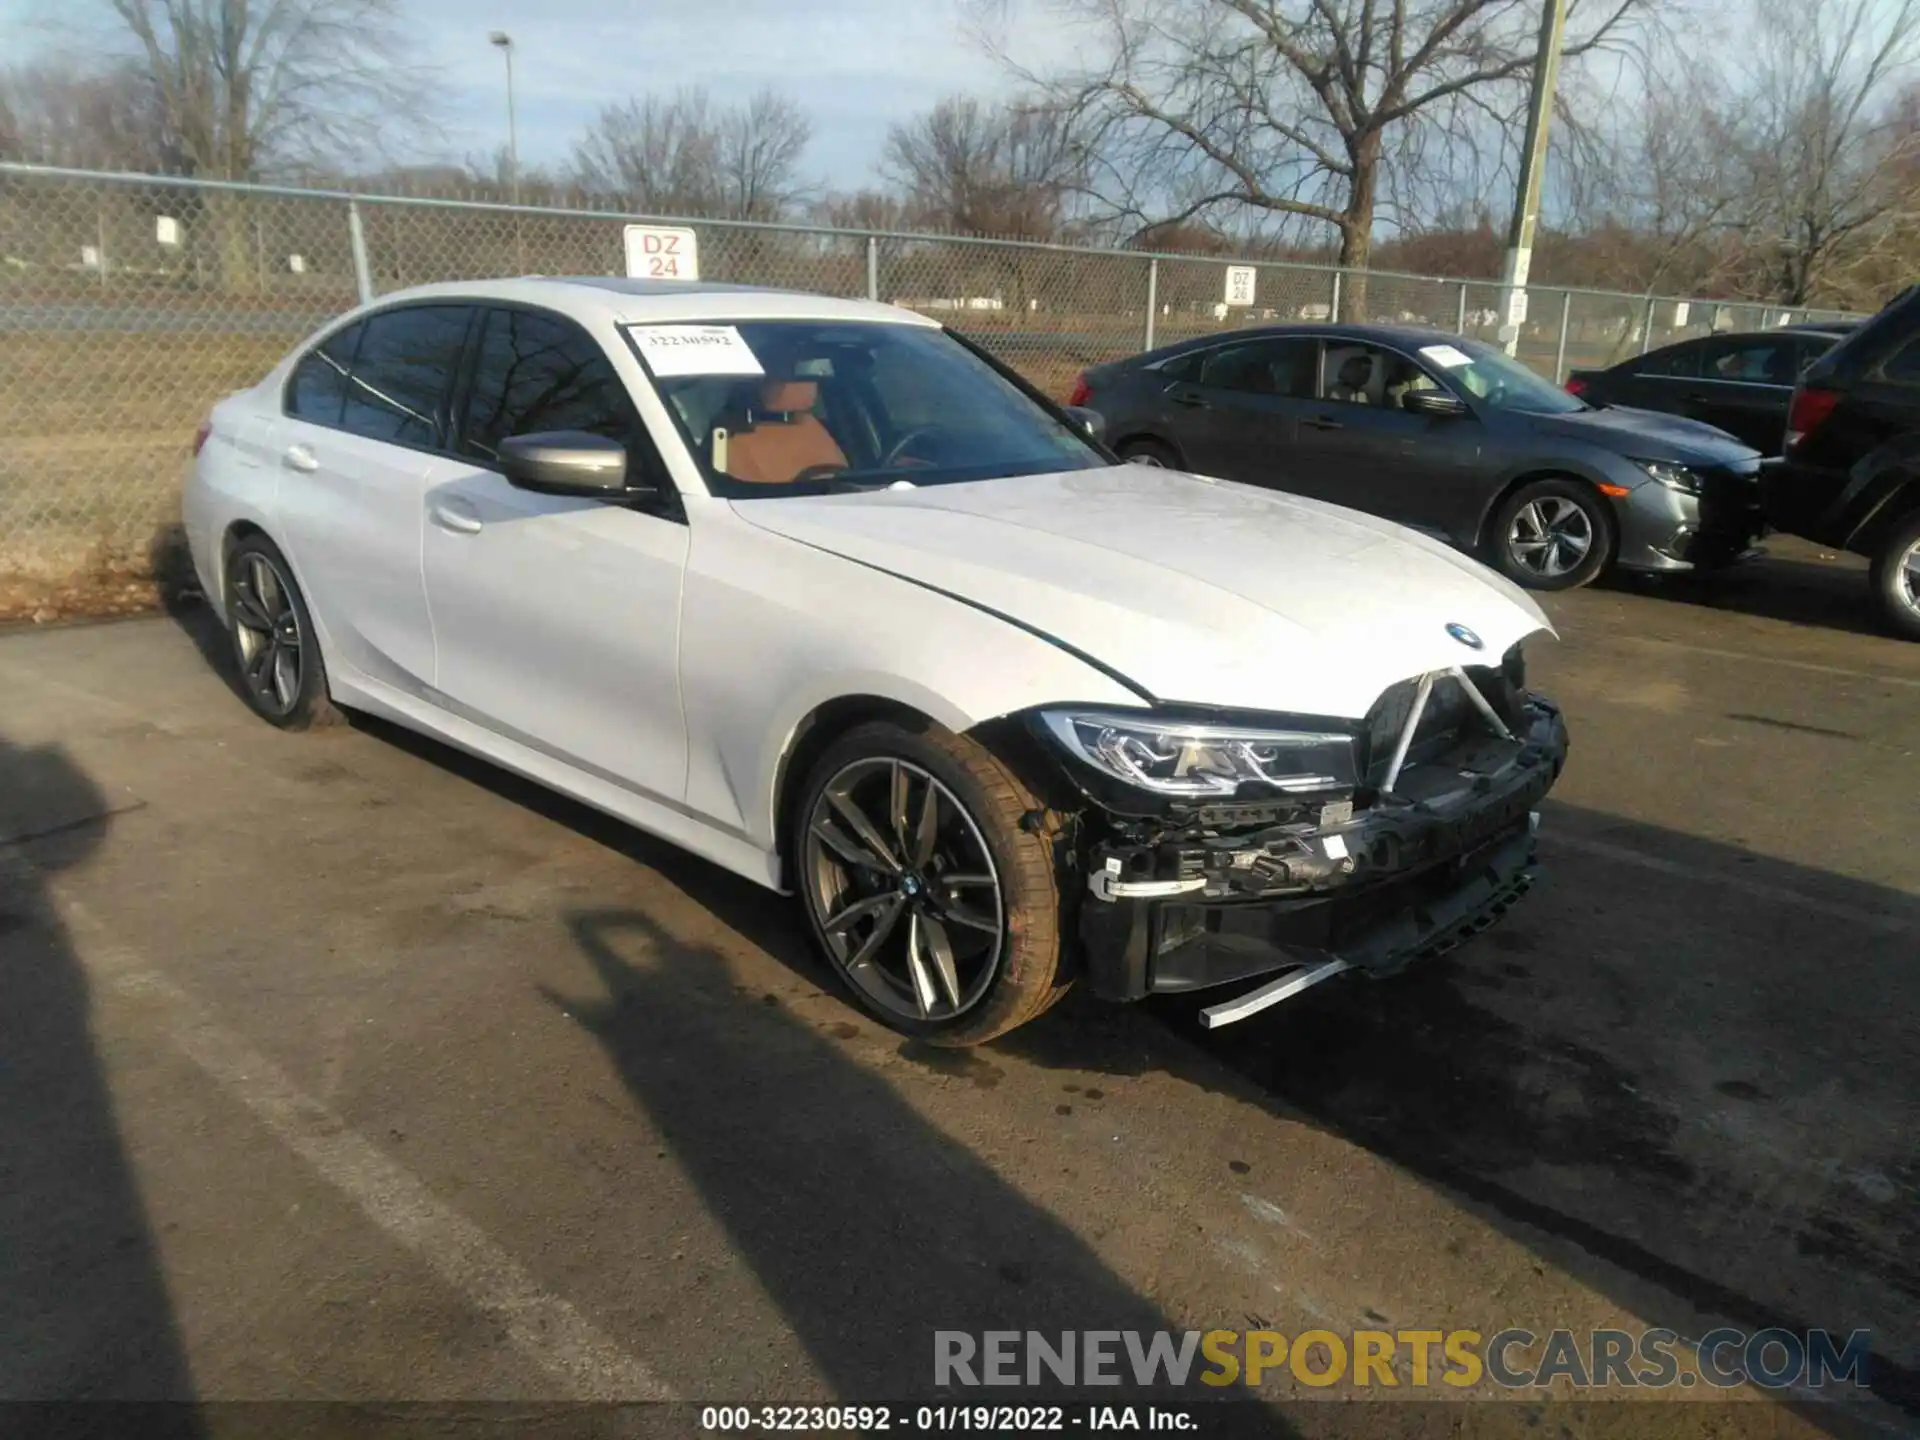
[549,910,1259,1404]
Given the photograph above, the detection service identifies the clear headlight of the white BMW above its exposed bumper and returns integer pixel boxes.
[1041,710,1356,799]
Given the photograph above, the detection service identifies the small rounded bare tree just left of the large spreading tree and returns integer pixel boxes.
[879,96,1085,240]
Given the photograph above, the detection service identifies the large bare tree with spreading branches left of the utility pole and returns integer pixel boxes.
[975,0,1645,267]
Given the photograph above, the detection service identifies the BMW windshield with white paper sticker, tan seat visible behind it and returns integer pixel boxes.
[626,321,1108,499]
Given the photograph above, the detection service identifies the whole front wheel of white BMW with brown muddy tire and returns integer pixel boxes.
[789,722,1068,1046]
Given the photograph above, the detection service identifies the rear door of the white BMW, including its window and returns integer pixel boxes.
[278,305,472,695]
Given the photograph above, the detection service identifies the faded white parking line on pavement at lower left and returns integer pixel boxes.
[0,851,674,1402]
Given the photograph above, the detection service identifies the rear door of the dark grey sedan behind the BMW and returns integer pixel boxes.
[1167,336,1319,490]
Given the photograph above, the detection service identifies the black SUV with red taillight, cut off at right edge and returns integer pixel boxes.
[1761,286,1920,639]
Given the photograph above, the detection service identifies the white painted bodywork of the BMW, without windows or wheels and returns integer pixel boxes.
[182,280,1546,887]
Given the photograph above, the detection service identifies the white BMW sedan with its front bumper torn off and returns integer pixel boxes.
[184,278,1567,1044]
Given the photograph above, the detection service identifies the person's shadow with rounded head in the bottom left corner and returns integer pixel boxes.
[0,737,200,1436]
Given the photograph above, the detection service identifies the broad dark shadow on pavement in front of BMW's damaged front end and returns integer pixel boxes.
[1000,806,1920,1417]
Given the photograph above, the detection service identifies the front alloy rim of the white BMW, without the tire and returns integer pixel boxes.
[804,756,1006,1023]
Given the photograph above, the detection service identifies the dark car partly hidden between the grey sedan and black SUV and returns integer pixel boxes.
[1567,324,1853,455]
